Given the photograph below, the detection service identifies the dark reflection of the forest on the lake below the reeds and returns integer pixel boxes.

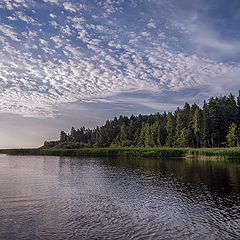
[57,157,240,212]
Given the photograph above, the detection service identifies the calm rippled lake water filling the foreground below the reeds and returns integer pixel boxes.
[0,155,240,240]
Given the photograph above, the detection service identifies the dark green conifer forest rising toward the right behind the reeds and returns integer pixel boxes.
[43,91,240,149]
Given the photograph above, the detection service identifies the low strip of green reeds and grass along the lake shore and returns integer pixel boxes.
[0,148,240,159]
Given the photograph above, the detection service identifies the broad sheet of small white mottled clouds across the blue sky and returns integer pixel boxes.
[0,0,240,117]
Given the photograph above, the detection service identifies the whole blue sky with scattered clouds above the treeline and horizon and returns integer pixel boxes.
[0,0,240,148]
